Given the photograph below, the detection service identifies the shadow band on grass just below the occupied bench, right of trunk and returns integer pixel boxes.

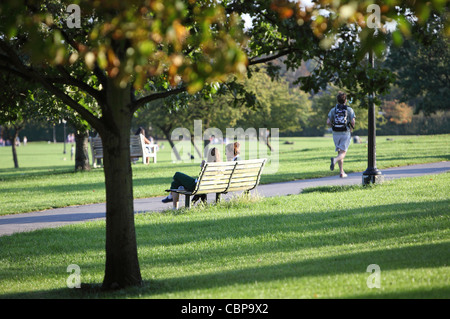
[136,200,449,256]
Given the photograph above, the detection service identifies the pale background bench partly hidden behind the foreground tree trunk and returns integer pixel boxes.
[91,135,157,167]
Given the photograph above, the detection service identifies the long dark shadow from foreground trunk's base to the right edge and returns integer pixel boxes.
[137,243,450,298]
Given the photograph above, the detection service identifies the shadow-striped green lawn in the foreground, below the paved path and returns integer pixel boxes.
[0,172,450,299]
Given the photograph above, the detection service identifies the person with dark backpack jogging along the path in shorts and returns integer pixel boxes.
[327,92,355,178]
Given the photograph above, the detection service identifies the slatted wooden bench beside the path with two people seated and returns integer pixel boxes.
[166,158,266,208]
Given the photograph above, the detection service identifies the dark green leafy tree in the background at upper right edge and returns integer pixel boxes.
[385,14,450,114]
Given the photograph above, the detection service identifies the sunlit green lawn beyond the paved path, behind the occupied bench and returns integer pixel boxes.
[0,134,450,215]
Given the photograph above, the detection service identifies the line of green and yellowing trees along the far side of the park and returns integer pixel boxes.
[7,51,450,147]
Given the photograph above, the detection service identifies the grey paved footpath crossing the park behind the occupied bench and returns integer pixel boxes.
[0,161,450,236]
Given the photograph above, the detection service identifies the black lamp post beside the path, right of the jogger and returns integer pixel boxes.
[362,50,384,185]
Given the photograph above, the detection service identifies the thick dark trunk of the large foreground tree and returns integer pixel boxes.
[100,80,142,289]
